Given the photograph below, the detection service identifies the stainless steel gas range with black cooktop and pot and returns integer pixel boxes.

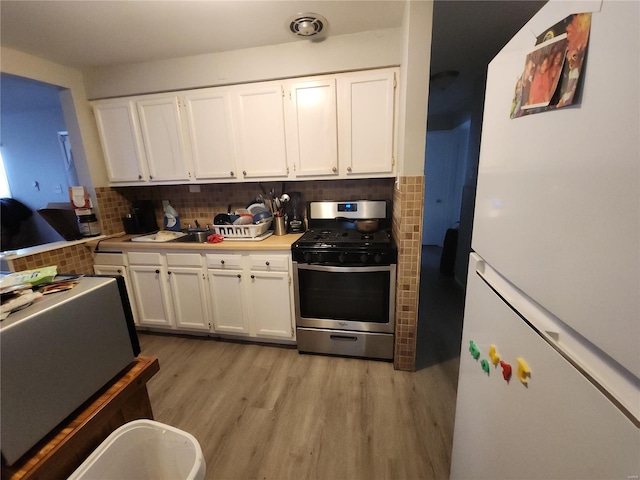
[291,200,398,360]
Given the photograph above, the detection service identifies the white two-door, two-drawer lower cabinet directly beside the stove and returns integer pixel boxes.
[206,252,295,340]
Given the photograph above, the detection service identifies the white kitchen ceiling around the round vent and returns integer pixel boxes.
[0,0,404,69]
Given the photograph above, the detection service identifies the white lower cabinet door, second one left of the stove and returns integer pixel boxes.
[209,269,249,335]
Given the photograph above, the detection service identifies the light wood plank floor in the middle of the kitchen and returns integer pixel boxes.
[140,246,459,480]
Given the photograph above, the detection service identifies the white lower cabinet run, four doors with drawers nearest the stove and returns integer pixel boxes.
[127,251,295,343]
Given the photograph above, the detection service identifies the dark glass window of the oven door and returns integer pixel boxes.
[298,269,390,323]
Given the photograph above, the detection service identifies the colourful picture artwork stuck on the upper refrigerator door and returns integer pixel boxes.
[511,13,591,118]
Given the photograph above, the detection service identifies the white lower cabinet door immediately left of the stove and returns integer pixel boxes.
[248,271,294,339]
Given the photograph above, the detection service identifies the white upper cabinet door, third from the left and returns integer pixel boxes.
[184,88,238,180]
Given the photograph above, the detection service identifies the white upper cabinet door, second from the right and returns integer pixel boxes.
[287,78,338,177]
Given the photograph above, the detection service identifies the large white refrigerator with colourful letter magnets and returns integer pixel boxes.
[451,0,640,480]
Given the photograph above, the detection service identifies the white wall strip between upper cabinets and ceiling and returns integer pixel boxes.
[84,29,402,100]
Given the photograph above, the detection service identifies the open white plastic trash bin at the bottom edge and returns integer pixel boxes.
[69,420,206,480]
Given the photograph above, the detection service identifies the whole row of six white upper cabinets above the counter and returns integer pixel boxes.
[93,68,398,185]
